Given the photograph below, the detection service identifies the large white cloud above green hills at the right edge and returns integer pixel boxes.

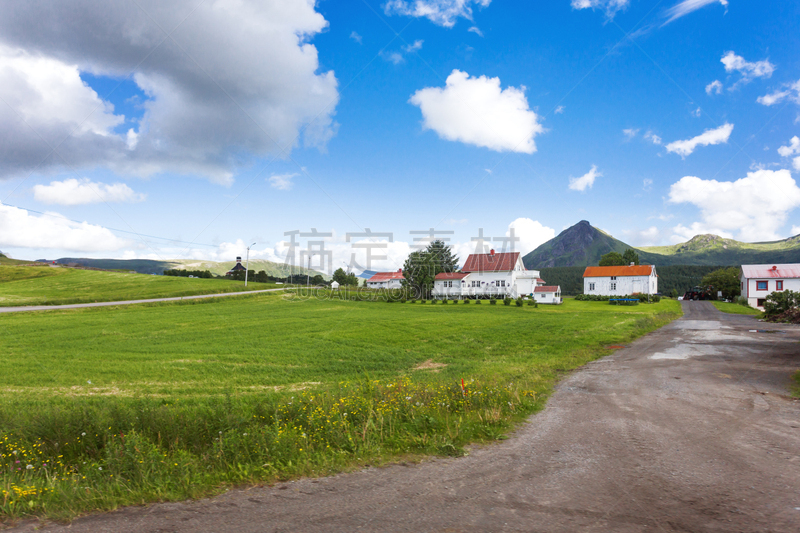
[669,170,800,242]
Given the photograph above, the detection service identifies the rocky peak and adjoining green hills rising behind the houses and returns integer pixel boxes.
[522,220,800,269]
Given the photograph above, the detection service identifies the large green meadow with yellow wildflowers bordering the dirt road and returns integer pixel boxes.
[0,295,680,518]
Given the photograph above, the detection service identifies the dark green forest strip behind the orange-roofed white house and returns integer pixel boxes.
[539,265,725,296]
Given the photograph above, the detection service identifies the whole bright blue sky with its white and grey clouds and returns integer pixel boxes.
[0,0,800,269]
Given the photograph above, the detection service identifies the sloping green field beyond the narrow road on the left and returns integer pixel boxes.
[0,266,280,307]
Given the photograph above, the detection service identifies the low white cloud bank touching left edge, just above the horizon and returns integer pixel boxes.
[0,204,130,252]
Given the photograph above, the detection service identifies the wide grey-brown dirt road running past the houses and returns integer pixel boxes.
[7,302,800,533]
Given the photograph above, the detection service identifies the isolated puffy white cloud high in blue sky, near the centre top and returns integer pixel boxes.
[409,70,544,154]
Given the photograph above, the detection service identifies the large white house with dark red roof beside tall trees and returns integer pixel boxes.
[432,250,544,298]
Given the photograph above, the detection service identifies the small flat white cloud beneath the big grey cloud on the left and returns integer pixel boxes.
[33,178,146,205]
